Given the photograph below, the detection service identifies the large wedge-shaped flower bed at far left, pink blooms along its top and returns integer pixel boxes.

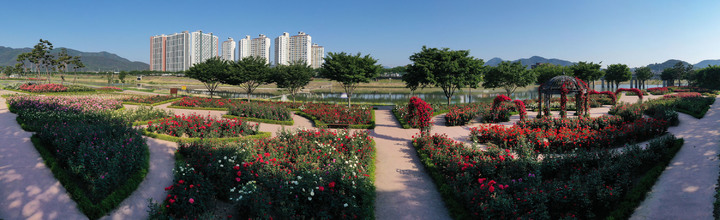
[7,96,149,219]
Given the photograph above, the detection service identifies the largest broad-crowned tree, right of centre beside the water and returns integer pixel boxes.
[402,46,485,105]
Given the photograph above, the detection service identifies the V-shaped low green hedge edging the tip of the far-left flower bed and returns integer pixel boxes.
[31,134,150,219]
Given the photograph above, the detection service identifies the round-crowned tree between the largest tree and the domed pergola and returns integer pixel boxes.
[483,61,537,96]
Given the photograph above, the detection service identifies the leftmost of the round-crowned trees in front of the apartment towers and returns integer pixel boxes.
[185,57,231,98]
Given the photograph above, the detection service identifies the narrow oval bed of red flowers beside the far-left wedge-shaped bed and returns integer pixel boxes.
[147,114,260,138]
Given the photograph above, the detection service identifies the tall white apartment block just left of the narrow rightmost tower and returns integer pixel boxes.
[275,32,312,65]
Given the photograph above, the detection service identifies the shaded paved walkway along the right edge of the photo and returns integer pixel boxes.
[631,96,720,219]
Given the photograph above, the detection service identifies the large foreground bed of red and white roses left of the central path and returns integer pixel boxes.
[150,130,375,219]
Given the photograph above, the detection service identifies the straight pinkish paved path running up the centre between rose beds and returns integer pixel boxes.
[370,106,450,220]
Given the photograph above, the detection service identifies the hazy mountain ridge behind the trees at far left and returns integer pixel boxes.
[0,46,150,72]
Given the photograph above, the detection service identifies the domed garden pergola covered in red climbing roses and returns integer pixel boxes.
[538,75,589,117]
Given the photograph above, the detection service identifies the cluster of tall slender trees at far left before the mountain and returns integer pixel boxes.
[0,39,85,82]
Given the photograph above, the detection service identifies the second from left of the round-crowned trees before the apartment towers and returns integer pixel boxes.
[229,56,272,102]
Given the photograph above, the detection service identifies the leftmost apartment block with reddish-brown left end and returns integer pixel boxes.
[150,31,219,72]
